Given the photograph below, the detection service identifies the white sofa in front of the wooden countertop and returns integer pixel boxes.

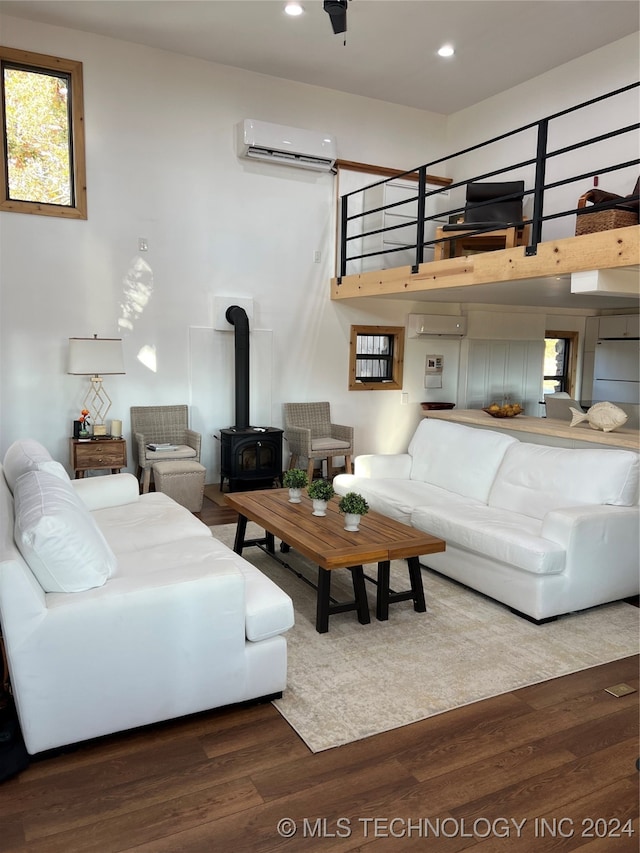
[333,418,640,621]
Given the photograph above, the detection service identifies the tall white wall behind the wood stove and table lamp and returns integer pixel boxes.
[0,17,445,480]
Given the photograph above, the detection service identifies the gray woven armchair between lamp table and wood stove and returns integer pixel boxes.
[130,406,202,494]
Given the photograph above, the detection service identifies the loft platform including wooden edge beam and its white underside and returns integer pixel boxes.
[331,225,640,309]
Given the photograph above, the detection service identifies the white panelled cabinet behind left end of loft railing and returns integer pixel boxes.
[362,180,444,272]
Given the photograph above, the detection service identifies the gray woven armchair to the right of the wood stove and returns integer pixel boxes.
[284,403,353,481]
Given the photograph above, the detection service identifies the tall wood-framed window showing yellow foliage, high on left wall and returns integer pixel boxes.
[0,47,87,219]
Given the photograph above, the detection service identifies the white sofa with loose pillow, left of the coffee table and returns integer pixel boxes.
[0,440,293,754]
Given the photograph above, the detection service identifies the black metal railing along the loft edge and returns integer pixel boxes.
[338,82,640,281]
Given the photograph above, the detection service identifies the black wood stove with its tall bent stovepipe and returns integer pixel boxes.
[220,305,283,492]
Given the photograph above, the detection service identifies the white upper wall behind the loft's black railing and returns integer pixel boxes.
[447,33,640,240]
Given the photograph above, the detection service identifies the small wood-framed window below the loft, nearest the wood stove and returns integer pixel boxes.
[349,326,404,391]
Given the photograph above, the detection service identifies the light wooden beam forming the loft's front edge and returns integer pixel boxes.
[331,225,640,307]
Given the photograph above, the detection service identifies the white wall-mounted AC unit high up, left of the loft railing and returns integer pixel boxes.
[237,118,337,172]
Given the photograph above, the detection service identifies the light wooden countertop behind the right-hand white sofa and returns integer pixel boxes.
[424,409,640,450]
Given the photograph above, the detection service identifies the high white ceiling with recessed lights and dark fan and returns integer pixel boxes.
[0,0,640,114]
